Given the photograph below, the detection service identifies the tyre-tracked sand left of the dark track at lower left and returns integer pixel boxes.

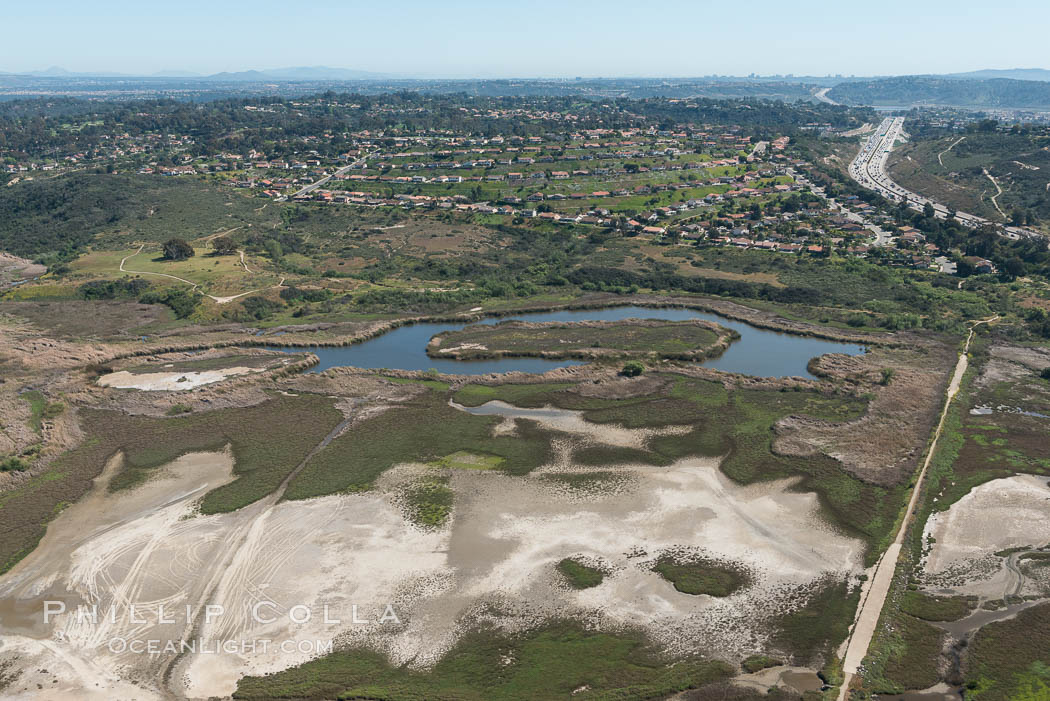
[0,452,233,699]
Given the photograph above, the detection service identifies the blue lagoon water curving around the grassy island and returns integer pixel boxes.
[264,306,865,378]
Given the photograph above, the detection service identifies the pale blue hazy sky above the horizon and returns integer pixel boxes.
[0,0,1050,77]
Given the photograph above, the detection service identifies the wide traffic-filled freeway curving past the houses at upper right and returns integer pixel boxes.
[849,116,1038,238]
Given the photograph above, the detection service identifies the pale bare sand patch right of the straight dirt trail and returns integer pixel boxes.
[923,474,1050,598]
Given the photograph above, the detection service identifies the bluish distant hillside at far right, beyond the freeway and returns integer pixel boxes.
[827,76,1050,108]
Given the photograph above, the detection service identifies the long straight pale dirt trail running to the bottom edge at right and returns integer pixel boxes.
[838,317,999,701]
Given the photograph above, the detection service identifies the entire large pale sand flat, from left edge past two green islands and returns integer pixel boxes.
[0,407,862,699]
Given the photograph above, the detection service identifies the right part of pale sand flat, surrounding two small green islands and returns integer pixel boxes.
[449,460,862,654]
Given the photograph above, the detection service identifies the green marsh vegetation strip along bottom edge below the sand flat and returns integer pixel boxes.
[234,623,733,701]
